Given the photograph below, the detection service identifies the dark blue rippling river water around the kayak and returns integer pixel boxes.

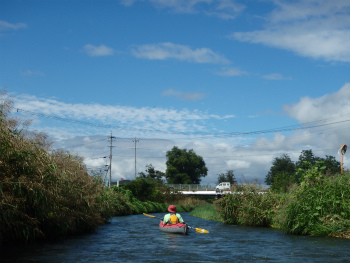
[0,213,350,263]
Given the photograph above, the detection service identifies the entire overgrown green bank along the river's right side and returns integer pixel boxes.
[209,167,350,238]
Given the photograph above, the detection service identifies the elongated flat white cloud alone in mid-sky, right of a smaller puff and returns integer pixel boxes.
[132,42,230,64]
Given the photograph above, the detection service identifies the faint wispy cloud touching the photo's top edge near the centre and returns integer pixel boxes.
[121,0,245,20]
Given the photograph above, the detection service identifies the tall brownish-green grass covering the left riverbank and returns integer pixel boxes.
[0,92,127,244]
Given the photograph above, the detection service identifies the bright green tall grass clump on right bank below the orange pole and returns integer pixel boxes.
[277,173,350,236]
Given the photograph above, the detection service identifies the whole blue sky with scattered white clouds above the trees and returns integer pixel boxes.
[0,0,350,186]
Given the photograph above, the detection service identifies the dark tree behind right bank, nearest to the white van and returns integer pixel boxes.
[265,154,295,185]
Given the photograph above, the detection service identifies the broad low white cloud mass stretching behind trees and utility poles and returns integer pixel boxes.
[15,83,350,186]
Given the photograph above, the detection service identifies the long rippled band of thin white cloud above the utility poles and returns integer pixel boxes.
[16,93,228,134]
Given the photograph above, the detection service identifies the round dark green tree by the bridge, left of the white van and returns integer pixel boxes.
[165,146,208,184]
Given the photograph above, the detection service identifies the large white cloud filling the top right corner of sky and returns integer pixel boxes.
[230,0,350,62]
